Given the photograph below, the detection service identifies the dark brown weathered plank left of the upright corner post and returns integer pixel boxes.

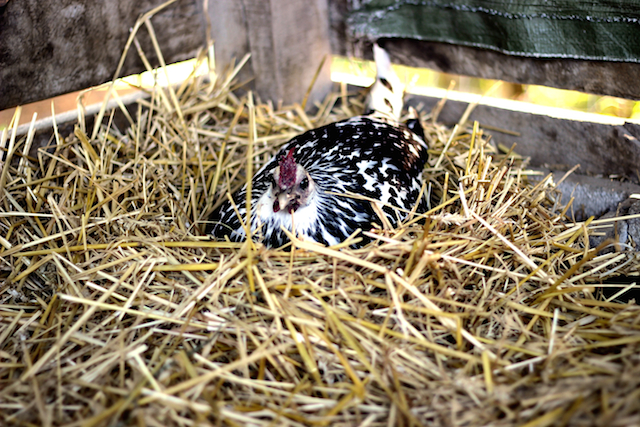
[0,0,205,109]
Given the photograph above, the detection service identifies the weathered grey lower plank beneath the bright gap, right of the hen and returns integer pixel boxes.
[407,96,640,179]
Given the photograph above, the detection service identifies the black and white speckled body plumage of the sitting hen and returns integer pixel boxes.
[212,116,427,247]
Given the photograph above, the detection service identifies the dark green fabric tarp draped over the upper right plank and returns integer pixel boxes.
[348,0,640,62]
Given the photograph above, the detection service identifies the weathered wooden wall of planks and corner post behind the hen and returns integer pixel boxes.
[0,0,640,180]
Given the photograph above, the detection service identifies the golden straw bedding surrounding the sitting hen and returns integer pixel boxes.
[0,13,640,426]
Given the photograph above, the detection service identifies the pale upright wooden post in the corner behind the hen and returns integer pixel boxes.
[209,0,331,103]
